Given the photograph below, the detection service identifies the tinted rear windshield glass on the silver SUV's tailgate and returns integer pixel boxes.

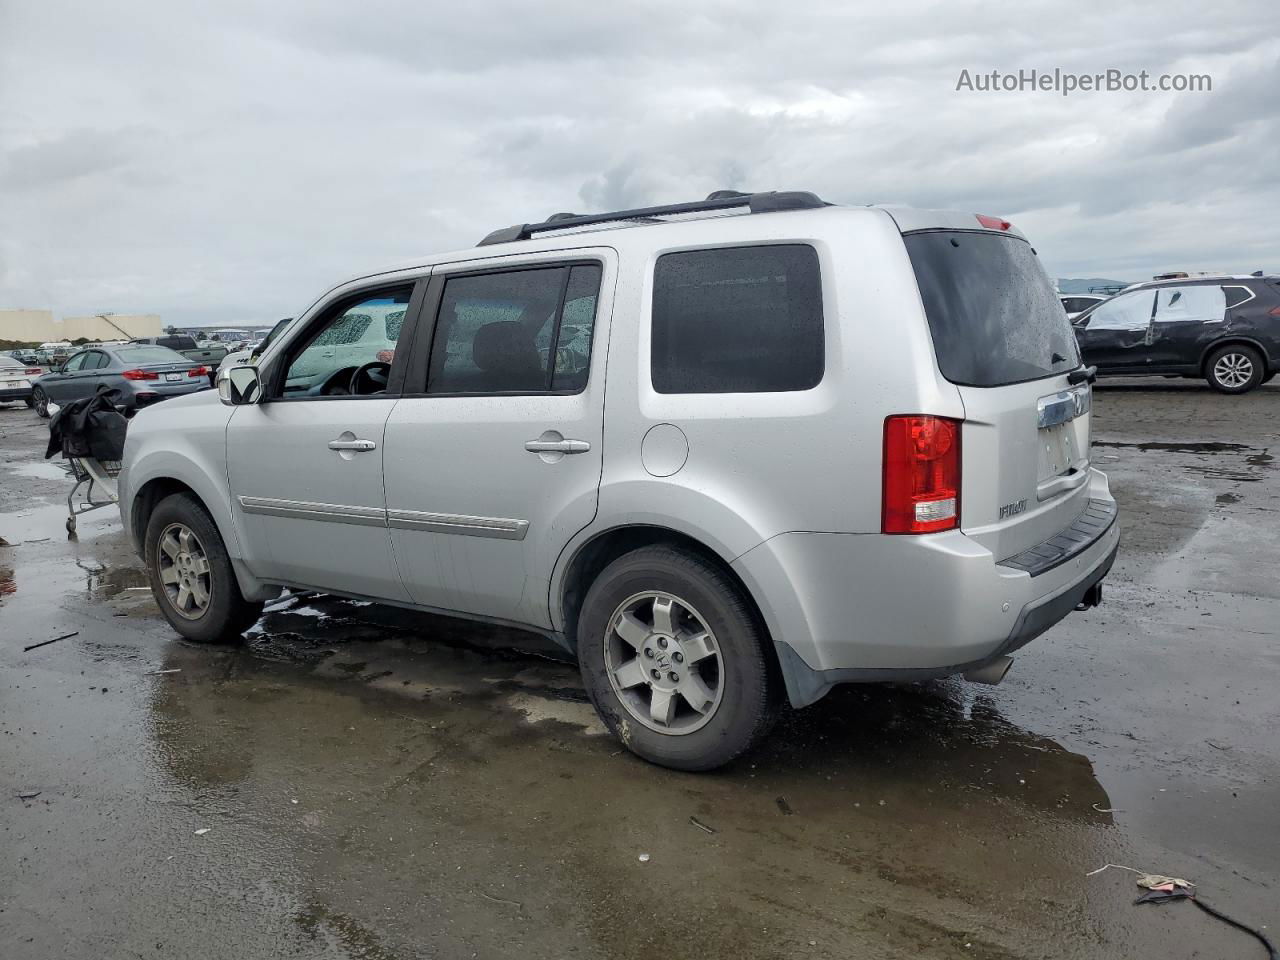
[902,230,1080,387]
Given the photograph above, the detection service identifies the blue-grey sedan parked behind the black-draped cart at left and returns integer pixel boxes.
[32,343,210,417]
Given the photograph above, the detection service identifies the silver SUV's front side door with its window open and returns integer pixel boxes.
[227,284,413,600]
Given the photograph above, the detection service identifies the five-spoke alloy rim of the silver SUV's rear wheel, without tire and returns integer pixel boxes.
[604,591,724,735]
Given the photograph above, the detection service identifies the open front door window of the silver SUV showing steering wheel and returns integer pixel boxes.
[284,285,413,397]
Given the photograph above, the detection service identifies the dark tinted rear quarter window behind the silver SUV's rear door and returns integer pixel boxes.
[650,244,824,393]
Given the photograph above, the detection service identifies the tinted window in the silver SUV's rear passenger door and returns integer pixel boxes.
[426,264,600,393]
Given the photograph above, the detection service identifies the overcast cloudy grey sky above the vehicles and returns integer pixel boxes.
[0,0,1280,324]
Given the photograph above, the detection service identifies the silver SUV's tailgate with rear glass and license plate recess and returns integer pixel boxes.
[904,230,1092,559]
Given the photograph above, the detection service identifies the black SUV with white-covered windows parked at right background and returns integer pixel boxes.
[1071,275,1280,393]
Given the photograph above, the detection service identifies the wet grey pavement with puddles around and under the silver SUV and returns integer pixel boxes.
[0,380,1280,960]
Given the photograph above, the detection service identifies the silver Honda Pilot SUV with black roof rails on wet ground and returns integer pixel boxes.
[120,192,1120,769]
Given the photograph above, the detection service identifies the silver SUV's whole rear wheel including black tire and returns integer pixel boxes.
[577,545,782,771]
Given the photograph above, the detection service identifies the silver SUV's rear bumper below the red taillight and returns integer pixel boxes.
[733,471,1120,707]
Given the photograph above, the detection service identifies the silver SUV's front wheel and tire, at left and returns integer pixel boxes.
[145,493,262,643]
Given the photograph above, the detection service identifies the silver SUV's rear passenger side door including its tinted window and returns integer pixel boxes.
[384,259,613,626]
